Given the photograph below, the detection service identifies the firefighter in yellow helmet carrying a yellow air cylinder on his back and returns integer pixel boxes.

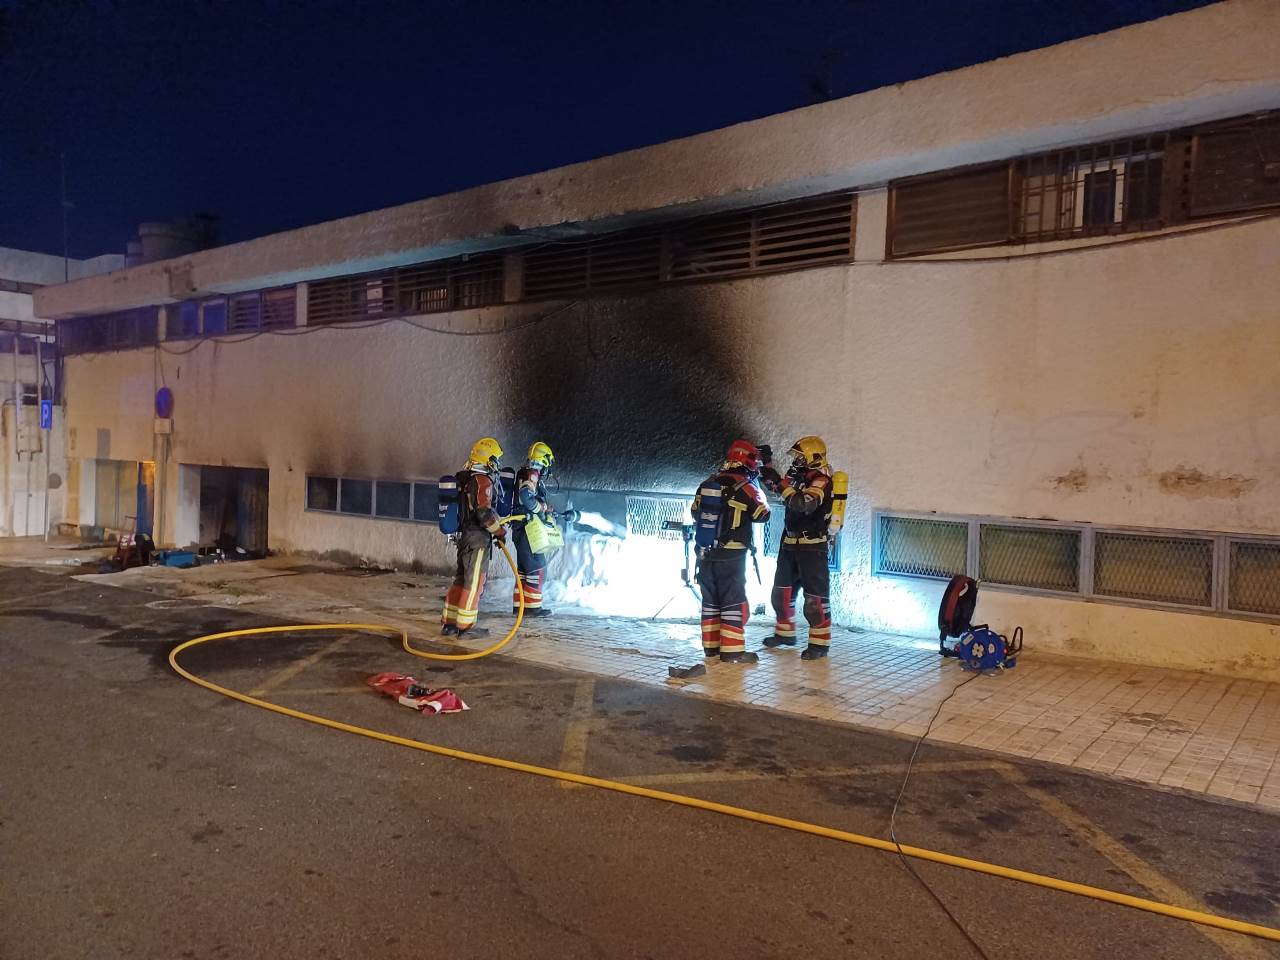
[764,436,833,660]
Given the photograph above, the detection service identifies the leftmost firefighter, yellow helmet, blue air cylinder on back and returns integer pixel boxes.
[440,436,507,636]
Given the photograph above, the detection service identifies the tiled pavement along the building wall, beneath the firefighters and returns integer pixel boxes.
[55,558,1280,810]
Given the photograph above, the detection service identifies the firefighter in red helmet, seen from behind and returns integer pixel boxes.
[694,440,769,663]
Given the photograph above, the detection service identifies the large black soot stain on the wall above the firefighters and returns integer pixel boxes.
[503,288,760,492]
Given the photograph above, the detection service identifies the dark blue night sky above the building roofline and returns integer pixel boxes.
[0,0,1204,257]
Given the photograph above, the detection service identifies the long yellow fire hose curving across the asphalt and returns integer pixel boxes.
[169,544,1280,941]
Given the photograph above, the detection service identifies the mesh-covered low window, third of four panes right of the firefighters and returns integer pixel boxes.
[1093,531,1213,607]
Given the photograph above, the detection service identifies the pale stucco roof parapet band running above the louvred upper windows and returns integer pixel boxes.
[36,0,1280,317]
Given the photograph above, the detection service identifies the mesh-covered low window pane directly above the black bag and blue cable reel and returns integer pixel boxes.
[978,524,1082,593]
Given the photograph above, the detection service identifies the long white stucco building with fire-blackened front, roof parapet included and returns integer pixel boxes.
[36,0,1280,678]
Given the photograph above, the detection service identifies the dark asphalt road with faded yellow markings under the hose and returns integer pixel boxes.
[0,568,1280,960]
